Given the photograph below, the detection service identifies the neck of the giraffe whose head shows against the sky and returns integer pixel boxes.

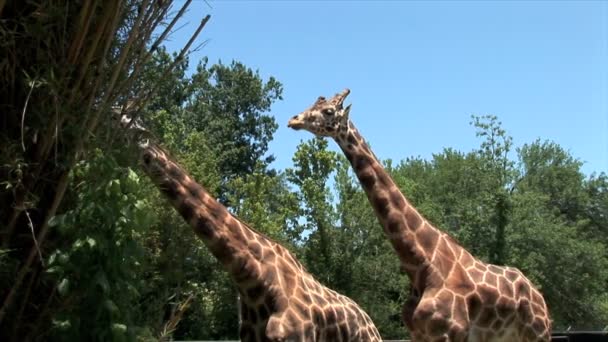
[335,122,462,291]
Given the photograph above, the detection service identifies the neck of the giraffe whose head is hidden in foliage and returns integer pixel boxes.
[142,144,283,288]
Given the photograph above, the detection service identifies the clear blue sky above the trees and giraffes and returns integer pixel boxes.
[167,0,608,173]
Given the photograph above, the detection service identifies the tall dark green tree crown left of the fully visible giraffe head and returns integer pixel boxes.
[185,59,283,190]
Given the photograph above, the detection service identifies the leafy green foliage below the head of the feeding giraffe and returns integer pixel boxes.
[46,150,153,341]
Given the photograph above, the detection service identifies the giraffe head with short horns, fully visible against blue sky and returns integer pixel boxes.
[287,89,350,137]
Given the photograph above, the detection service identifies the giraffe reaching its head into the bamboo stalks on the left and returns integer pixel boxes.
[121,115,381,342]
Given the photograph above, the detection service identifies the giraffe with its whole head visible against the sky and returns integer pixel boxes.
[288,89,551,341]
